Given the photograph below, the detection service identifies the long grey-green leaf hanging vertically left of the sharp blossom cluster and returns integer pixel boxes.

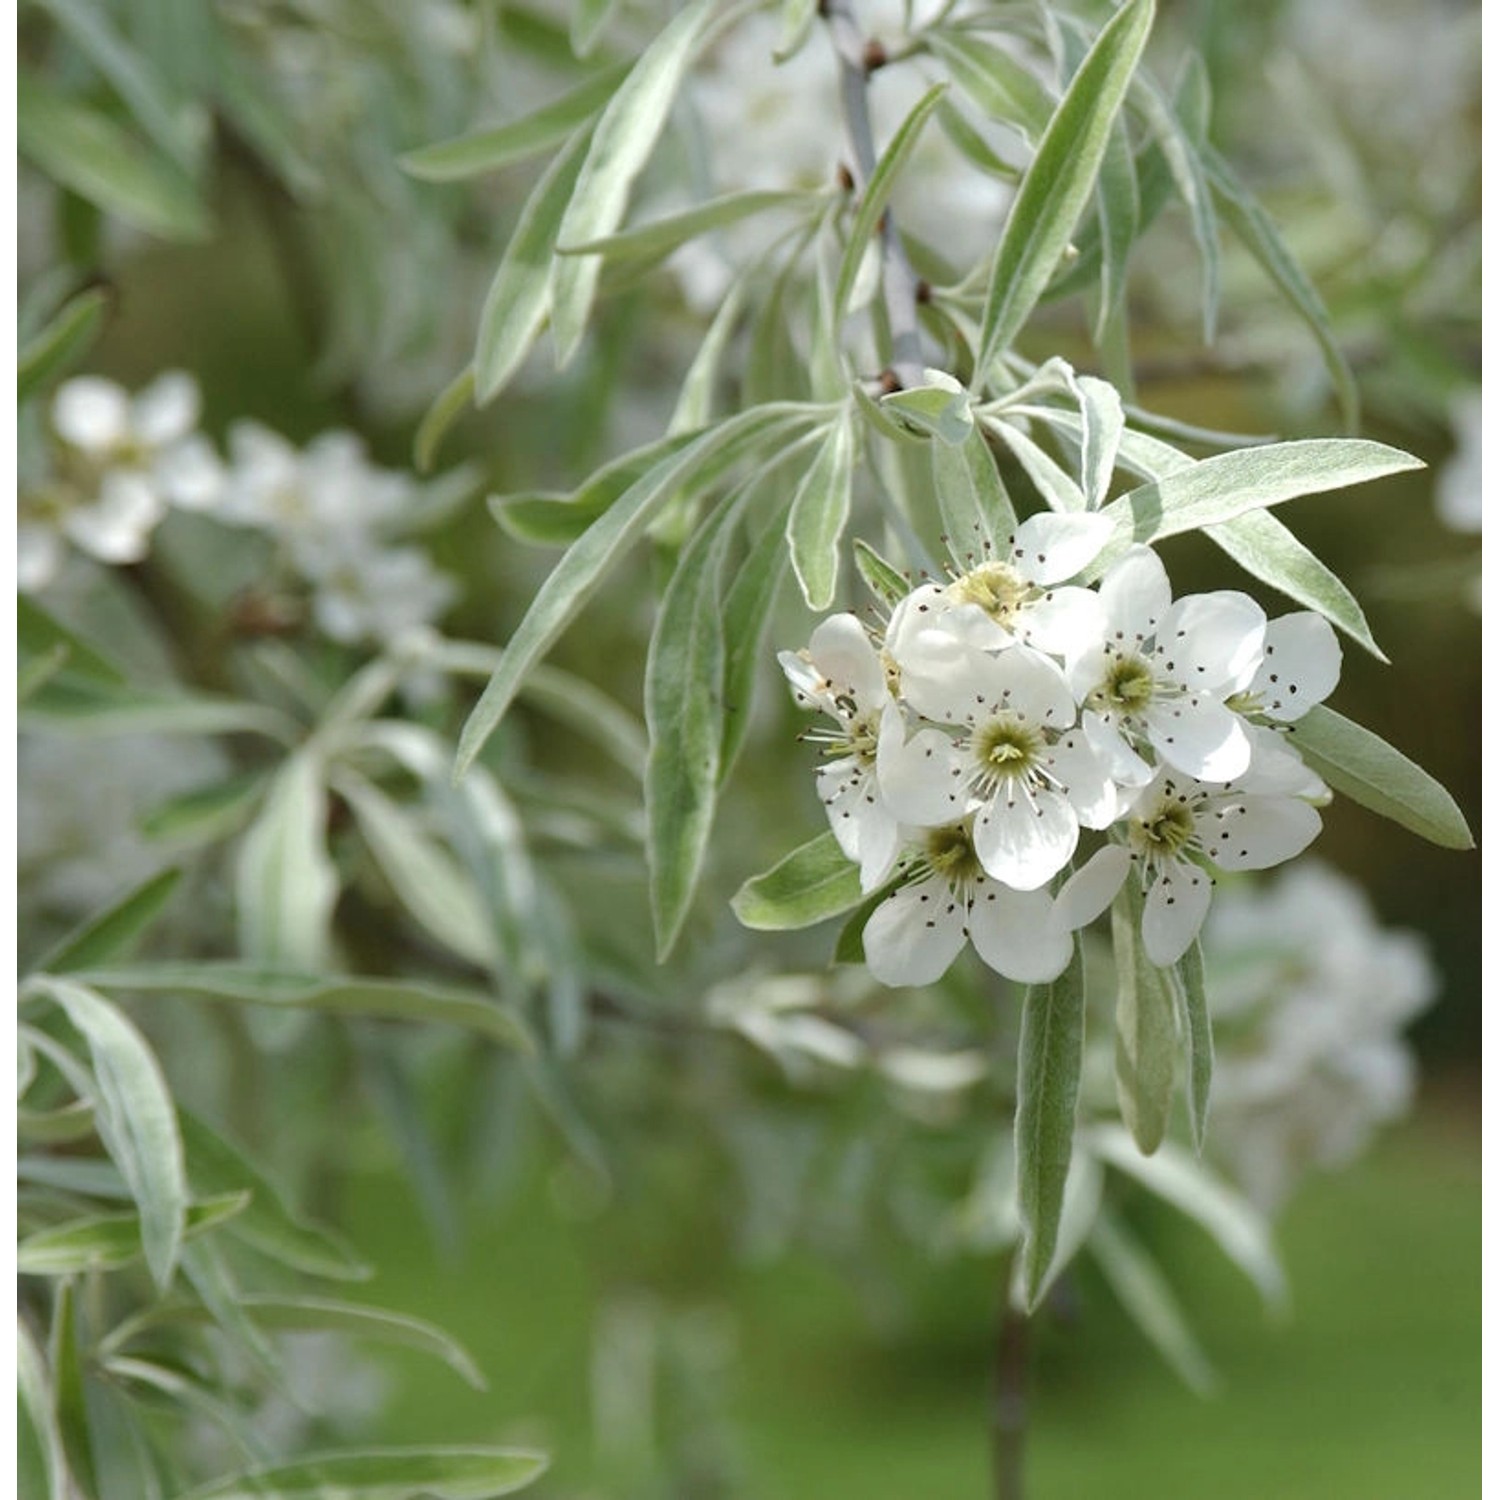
[645,504,738,962]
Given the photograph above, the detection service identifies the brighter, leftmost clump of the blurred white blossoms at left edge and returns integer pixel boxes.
[17,371,224,593]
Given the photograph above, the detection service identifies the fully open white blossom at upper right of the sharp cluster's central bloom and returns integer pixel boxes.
[1068,546,1266,785]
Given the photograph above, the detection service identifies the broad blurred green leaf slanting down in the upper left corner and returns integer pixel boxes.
[15,69,210,240]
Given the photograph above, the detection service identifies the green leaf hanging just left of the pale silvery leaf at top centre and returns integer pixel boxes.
[474,129,590,407]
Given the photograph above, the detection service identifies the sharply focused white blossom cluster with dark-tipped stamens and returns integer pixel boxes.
[780,513,1341,986]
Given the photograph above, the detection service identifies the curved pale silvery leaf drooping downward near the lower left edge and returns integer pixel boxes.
[33,975,188,1287]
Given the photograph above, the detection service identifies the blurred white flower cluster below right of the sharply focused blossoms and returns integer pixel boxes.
[1205,861,1437,1211]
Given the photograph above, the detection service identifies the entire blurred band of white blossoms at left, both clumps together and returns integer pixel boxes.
[18,371,456,645]
